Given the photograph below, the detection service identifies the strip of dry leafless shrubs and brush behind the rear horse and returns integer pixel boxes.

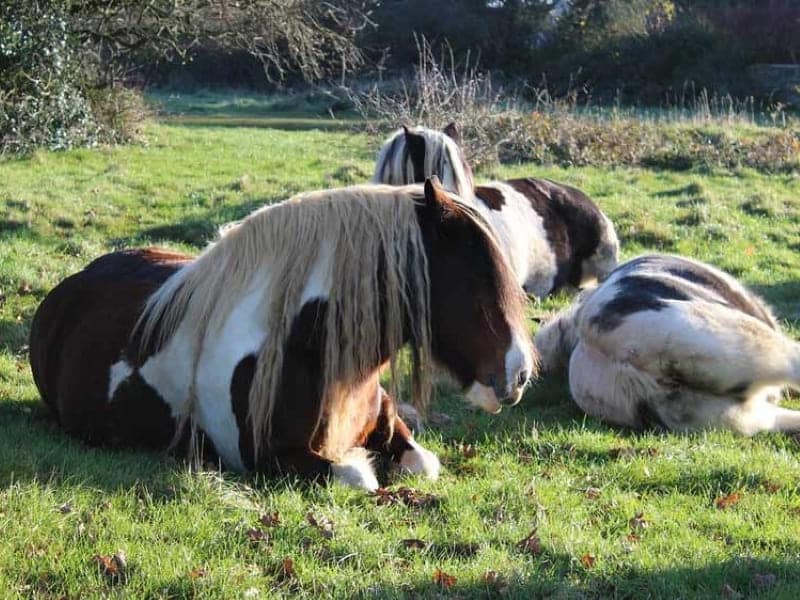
[348,39,800,172]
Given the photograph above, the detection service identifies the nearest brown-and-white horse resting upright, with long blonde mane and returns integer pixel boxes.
[30,181,536,489]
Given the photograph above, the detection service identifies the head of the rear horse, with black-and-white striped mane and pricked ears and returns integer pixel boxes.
[372,123,474,200]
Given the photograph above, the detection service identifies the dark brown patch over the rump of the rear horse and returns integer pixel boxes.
[506,177,604,291]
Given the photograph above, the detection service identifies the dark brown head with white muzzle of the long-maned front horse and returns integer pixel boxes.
[418,178,537,413]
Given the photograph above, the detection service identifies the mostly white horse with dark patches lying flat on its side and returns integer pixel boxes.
[535,255,800,435]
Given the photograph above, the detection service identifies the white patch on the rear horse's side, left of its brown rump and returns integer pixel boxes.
[475,181,558,298]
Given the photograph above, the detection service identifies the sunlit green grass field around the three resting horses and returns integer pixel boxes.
[0,96,800,598]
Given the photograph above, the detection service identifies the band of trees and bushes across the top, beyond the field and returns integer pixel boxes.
[0,0,800,156]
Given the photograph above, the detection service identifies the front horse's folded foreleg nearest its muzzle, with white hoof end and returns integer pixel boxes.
[366,388,441,480]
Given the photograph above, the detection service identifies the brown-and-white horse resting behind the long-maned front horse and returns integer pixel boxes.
[372,123,619,298]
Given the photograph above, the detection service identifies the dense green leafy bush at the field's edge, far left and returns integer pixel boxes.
[0,0,145,155]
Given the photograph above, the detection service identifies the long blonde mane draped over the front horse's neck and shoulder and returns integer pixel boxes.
[137,186,431,459]
